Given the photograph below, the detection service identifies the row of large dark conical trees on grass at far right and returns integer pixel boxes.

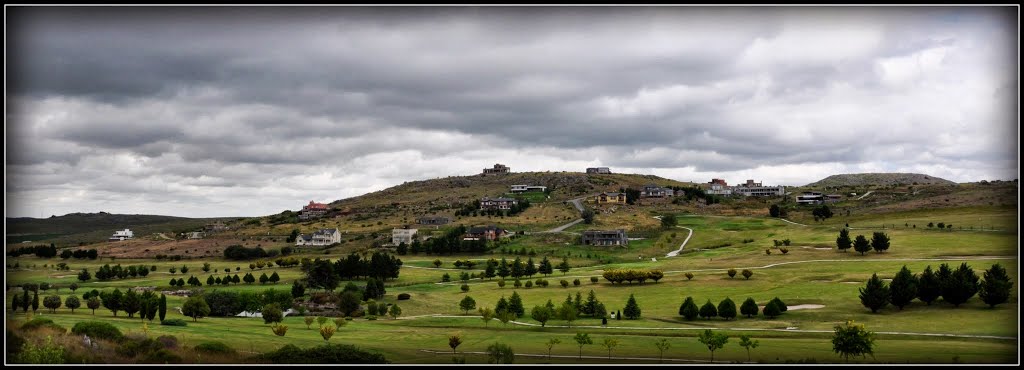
[860,262,1013,313]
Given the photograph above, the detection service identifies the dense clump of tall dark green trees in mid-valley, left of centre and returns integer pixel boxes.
[302,251,401,291]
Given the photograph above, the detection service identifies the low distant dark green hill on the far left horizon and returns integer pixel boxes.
[6,212,234,247]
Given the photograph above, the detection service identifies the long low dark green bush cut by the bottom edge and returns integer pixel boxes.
[259,344,390,364]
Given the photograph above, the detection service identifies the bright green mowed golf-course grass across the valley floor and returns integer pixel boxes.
[7,207,1019,363]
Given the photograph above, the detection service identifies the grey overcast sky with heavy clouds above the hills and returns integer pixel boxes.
[5,7,1019,217]
